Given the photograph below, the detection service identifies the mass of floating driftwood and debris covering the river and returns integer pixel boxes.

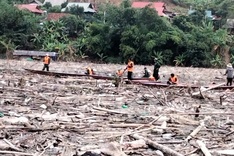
[0,60,234,156]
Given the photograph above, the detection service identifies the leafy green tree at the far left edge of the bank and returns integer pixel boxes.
[0,1,39,48]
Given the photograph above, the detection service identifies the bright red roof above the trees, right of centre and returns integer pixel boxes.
[132,2,165,16]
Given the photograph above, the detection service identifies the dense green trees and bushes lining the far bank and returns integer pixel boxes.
[0,0,234,67]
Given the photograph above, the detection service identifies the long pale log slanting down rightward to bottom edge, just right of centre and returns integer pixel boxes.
[132,134,183,156]
